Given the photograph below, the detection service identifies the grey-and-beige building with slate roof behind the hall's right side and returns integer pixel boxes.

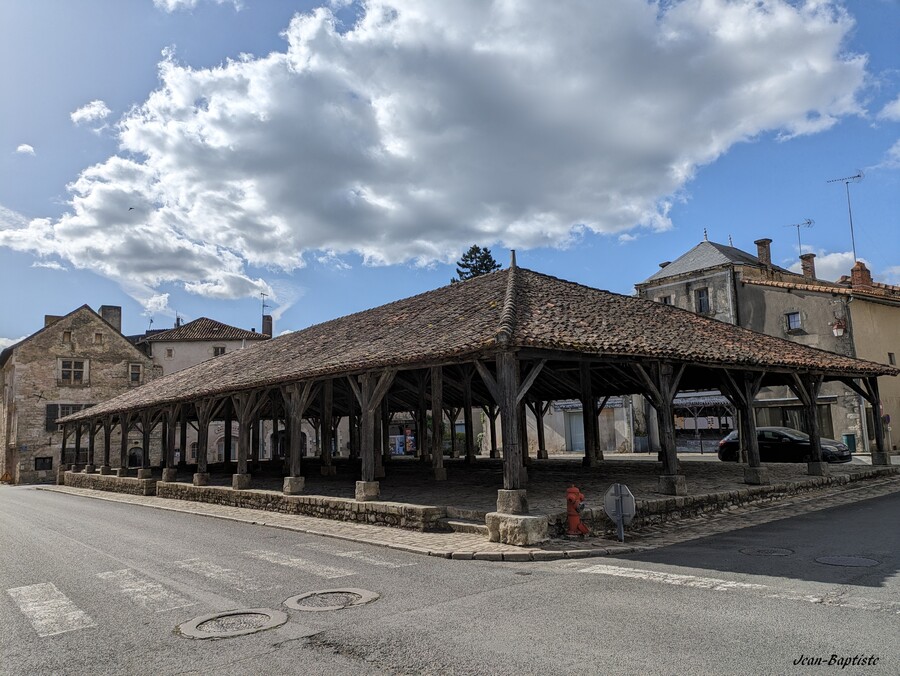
[635,239,900,451]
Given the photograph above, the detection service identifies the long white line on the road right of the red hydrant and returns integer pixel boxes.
[578,564,900,615]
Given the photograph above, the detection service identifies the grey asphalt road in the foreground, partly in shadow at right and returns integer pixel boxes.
[0,487,900,676]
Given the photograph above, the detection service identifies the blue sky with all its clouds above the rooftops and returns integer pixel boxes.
[0,0,900,347]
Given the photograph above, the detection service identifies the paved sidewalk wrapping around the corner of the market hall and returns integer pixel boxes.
[40,468,900,562]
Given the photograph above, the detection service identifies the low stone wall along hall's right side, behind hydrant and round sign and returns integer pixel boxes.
[549,467,900,537]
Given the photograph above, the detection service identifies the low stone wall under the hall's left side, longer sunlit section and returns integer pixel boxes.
[156,481,447,531]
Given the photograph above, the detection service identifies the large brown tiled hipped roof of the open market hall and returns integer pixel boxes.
[59,267,900,420]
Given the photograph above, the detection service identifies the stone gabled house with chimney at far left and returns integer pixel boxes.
[0,305,155,483]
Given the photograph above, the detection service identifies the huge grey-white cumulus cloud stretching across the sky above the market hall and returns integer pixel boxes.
[0,0,866,308]
